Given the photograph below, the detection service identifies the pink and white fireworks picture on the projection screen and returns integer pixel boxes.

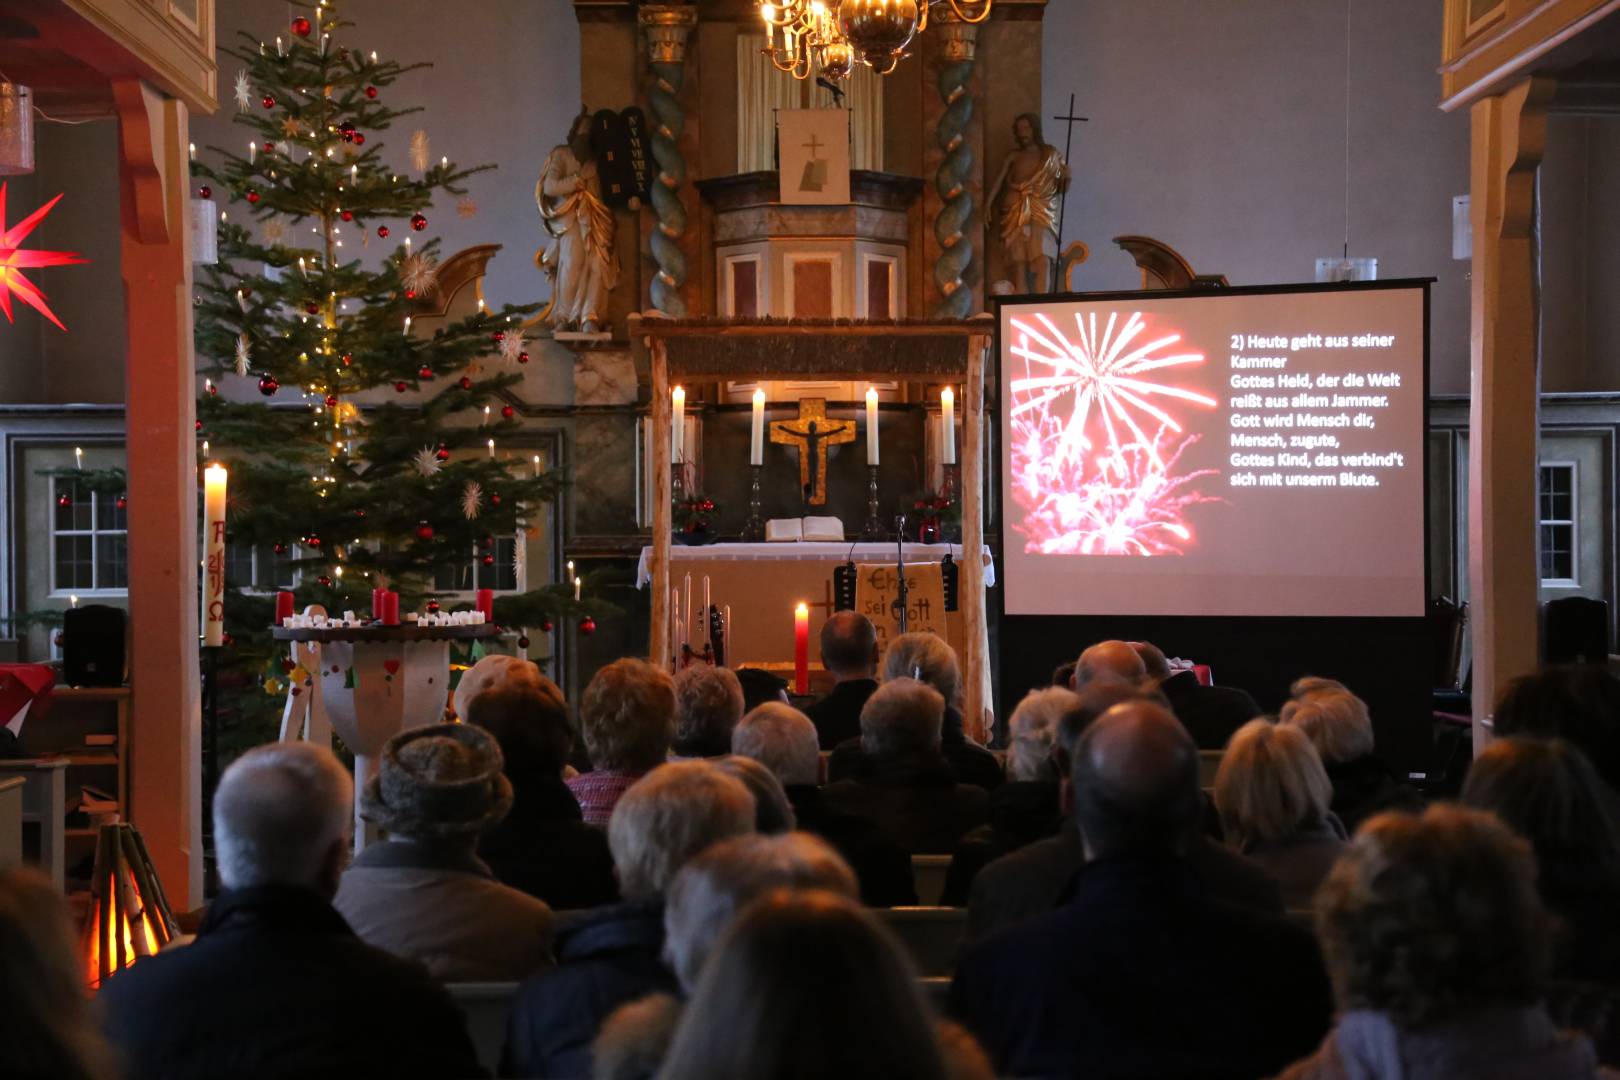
[1009,313,1218,555]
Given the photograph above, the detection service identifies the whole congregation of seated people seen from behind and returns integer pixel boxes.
[9,612,1620,1080]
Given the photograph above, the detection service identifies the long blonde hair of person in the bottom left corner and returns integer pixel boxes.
[0,866,117,1080]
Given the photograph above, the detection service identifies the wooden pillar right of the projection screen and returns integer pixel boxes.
[1468,79,1554,753]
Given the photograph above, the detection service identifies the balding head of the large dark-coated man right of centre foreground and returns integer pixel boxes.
[1071,701,1202,858]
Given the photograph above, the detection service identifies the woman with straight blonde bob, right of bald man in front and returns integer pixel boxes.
[1215,721,1345,910]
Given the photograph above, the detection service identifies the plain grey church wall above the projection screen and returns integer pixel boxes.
[1043,0,1469,393]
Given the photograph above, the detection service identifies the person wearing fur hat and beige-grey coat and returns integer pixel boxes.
[334,724,552,983]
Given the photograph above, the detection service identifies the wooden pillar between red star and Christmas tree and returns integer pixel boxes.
[113,79,203,908]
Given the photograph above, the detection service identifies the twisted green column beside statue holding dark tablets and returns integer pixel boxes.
[638,5,698,317]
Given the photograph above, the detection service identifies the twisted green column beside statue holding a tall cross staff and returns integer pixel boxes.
[933,18,978,319]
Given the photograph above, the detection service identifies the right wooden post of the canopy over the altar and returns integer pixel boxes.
[957,334,990,742]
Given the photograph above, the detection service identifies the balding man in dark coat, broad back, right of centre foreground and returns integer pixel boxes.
[949,703,1333,1080]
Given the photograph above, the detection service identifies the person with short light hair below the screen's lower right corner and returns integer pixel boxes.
[1277,689,1424,832]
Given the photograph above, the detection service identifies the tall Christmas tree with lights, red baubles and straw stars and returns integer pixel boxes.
[193,3,593,731]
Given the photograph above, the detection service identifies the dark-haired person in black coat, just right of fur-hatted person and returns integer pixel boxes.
[465,674,619,912]
